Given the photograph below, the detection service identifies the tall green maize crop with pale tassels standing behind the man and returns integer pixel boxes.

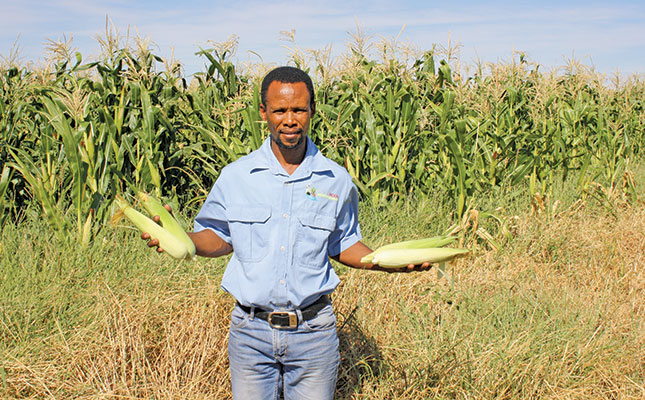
[0,31,645,242]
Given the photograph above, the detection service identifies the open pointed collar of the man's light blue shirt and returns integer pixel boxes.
[249,136,331,179]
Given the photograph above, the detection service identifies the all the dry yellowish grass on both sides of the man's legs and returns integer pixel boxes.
[0,198,645,399]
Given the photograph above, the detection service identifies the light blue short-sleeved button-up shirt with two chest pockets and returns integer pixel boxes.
[195,137,361,310]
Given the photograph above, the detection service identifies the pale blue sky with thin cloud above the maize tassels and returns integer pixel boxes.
[0,0,645,75]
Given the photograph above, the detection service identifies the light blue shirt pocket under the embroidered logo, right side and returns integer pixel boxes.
[294,214,336,268]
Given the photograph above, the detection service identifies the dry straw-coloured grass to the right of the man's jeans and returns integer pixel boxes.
[336,198,645,399]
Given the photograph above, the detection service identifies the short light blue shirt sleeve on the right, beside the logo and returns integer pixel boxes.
[327,182,362,257]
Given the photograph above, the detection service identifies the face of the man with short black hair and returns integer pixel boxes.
[260,81,314,149]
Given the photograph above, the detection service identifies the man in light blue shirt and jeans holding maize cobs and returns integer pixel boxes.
[143,67,430,400]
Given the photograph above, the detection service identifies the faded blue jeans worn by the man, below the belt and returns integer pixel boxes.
[228,304,340,400]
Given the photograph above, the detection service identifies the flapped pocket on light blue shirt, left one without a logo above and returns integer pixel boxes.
[226,206,271,262]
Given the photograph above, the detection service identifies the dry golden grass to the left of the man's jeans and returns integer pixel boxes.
[0,280,231,399]
